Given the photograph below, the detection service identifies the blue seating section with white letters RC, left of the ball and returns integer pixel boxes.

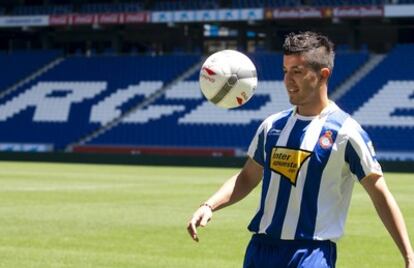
[0,55,200,150]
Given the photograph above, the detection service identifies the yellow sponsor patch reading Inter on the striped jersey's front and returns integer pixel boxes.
[270,147,312,186]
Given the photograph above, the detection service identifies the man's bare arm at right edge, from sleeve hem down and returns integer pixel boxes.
[361,174,414,268]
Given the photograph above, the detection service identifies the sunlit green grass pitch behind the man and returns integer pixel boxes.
[0,162,414,268]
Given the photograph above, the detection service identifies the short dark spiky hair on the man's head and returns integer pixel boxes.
[283,31,335,71]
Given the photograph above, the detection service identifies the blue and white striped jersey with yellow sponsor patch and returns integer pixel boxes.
[248,102,382,241]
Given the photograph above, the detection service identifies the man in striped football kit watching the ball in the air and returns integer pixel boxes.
[187,32,414,268]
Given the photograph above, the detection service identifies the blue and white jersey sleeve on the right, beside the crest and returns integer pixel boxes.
[345,124,383,181]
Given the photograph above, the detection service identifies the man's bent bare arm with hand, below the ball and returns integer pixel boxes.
[187,157,263,241]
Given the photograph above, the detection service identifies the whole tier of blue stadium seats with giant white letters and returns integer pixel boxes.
[0,45,414,159]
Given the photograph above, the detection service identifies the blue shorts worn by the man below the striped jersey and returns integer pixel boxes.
[243,234,336,268]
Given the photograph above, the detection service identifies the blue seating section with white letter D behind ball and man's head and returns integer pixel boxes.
[88,52,368,150]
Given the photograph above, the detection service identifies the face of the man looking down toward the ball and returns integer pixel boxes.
[283,55,322,107]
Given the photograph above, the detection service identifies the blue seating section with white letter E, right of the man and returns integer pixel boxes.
[337,45,414,157]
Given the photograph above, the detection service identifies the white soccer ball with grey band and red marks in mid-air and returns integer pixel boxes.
[199,50,257,109]
